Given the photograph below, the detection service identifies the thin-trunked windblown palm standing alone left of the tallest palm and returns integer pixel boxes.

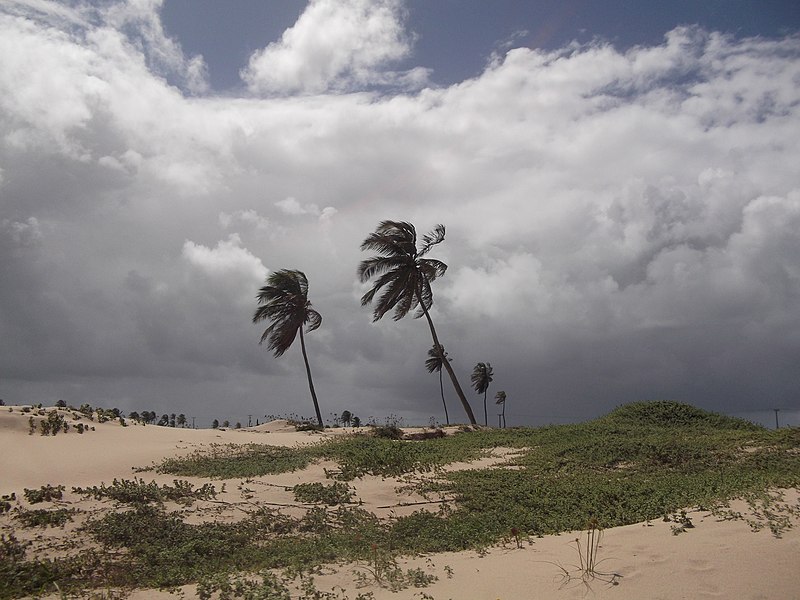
[253,269,324,427]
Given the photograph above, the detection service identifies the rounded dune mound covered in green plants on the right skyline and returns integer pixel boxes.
[599,401,763,431]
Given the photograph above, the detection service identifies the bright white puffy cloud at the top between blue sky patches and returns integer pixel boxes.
[241,0,427,95]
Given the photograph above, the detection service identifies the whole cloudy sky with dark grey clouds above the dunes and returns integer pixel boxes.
[0,0,800,427]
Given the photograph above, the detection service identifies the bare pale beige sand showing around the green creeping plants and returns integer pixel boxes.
[0,407,800,600]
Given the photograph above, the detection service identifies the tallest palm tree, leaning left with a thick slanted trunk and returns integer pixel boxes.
[358,221,475,425]
